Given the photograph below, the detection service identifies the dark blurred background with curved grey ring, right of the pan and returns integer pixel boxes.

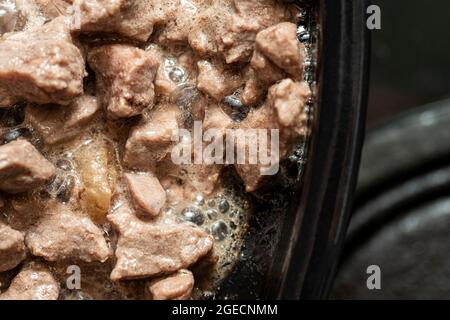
[332,0,450,299]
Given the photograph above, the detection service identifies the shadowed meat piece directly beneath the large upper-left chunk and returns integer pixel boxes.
[26,95,99,145]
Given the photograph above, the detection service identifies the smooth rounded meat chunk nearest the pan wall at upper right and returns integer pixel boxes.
[253,22,305,78]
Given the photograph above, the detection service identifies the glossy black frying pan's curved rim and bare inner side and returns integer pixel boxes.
[216,0,370,299]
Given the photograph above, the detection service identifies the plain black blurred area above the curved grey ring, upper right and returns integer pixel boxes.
[367,0,450,129]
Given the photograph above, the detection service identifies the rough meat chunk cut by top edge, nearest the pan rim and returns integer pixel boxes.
[185,0,295,63]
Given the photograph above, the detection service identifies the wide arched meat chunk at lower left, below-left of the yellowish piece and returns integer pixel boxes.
[25,207,111,262]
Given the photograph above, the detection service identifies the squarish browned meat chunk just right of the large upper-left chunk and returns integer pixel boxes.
[88,44,160,118]
